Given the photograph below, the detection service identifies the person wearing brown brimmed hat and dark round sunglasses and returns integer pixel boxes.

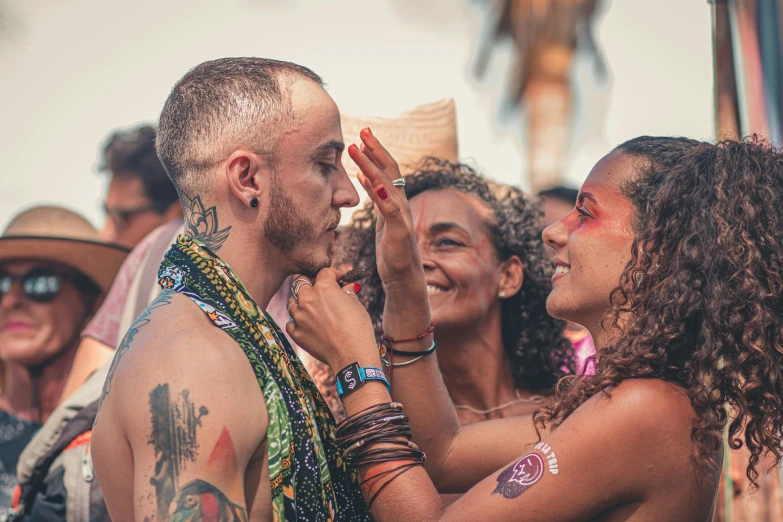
[0,202,128,516]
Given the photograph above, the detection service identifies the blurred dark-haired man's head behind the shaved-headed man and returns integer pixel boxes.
[99,125,182,248]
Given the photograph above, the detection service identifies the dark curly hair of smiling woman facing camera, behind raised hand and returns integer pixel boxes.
[338,158,574,390]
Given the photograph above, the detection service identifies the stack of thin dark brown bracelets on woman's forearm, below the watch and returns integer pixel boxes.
[337,402,426,509]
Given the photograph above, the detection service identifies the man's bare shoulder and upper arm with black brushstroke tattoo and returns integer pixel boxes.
[92,294,269,520]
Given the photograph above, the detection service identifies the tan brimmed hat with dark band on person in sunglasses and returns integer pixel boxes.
[0,205,130,294]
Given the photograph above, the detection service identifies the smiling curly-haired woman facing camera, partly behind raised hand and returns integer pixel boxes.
[340,158,575,424]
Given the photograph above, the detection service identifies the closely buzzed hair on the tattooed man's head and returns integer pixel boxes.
[155,58,323,194]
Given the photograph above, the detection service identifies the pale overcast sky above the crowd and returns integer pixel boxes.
[0,0,714,229]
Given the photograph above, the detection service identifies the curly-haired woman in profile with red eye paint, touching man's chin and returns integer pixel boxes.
[288,130,783,522]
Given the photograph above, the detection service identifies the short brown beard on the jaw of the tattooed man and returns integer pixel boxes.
[264,174,340,277]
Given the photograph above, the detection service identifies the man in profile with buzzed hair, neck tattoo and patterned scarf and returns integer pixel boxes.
[92,58,370,522]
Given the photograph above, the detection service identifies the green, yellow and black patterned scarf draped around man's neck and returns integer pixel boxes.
[158,235,371,522]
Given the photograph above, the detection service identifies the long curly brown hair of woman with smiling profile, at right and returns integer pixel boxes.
[536,136,783,485]
